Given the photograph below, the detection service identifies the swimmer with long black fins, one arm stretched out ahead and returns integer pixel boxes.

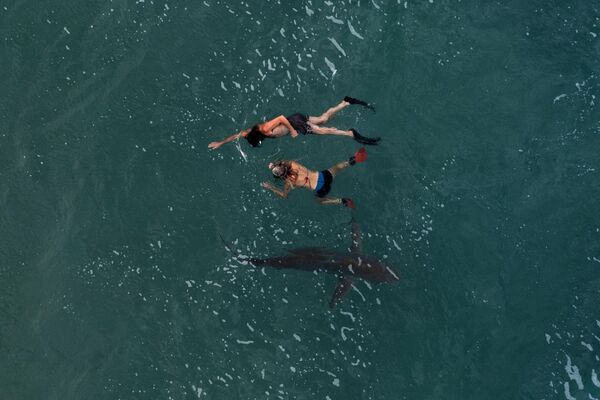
[208,96,380,150]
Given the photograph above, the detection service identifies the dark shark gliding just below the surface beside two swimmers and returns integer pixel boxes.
[223,222,400,307]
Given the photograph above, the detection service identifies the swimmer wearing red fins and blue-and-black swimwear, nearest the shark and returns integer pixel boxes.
[261,147,367,208]
